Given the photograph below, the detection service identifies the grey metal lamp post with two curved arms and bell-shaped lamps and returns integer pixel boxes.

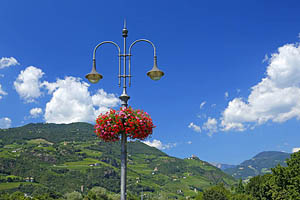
[85,23,164,200]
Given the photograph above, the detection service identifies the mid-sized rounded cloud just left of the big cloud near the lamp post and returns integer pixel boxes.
[14,66,44,103]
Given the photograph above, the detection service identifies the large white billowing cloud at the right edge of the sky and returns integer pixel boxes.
[221,44,300,131]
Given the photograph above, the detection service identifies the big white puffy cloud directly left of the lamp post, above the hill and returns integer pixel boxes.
[43,77,119,124]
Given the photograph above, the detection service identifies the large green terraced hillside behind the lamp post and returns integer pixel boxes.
[0,123,236,199]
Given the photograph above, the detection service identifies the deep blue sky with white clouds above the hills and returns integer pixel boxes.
[0,0,300,164]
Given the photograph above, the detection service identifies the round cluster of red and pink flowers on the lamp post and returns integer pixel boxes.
[95,107,155,142]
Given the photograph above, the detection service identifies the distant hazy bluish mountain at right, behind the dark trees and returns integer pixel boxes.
[224,151,290,180]
